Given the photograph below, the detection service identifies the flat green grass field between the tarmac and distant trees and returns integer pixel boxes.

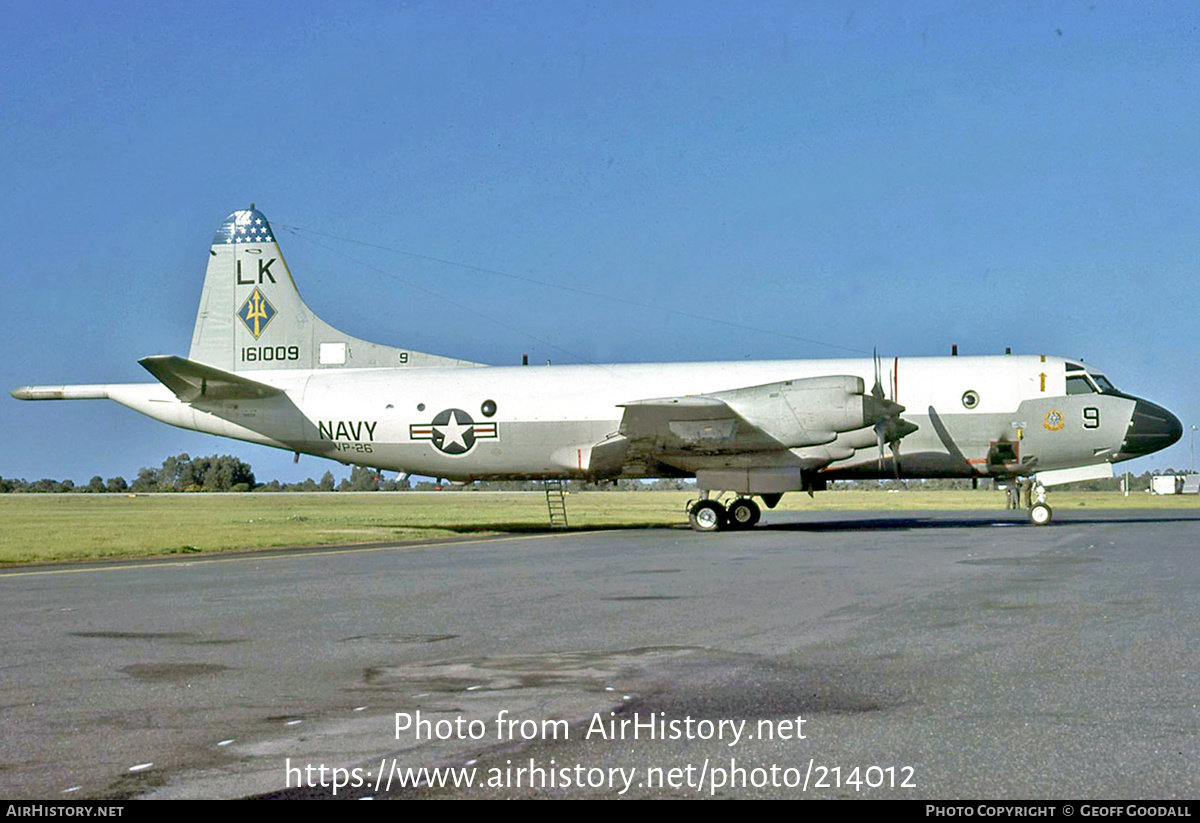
[0,491,1200,565]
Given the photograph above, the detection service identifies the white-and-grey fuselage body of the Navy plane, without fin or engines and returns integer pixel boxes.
[68,356,1171,489]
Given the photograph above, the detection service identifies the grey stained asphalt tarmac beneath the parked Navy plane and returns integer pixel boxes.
[0,509,1200,799]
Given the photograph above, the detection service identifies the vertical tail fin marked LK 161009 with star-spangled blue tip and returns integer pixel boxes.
[187,205,479,372]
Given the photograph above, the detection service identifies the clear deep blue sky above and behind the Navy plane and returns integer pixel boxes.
[0,0,1200,482]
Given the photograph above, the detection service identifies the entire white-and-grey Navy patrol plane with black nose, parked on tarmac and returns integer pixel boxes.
[12,205,1183,531]
